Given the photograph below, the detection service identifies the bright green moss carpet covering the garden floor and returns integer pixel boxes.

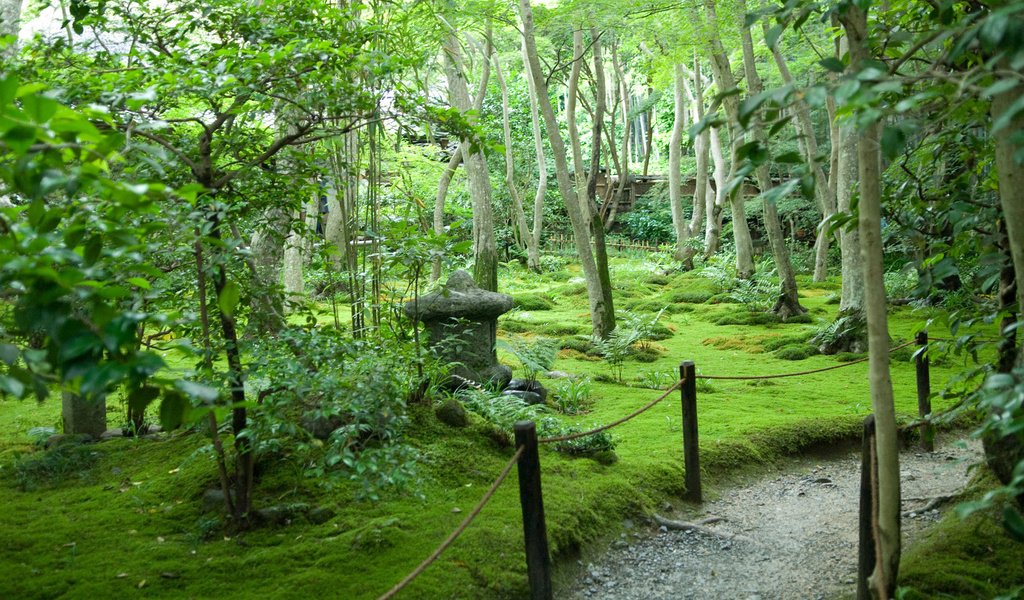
[0,254,1011,599]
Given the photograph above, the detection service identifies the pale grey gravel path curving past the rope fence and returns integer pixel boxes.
[556,434,981,600]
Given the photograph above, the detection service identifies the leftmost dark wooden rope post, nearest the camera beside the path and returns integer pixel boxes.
[515,421,553,600]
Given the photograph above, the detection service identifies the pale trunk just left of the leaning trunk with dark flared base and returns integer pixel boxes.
[705,0,754,280]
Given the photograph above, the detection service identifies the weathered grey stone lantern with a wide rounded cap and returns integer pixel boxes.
[404,270,513,387]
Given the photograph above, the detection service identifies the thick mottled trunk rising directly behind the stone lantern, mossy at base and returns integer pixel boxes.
[444,32,498,292]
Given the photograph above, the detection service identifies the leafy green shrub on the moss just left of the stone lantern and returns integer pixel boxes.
[250,329,418,500]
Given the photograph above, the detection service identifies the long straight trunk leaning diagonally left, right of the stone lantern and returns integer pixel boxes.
[519,0,613,338]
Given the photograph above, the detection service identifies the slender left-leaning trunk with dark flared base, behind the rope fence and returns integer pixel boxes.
[737,14,807,320]
